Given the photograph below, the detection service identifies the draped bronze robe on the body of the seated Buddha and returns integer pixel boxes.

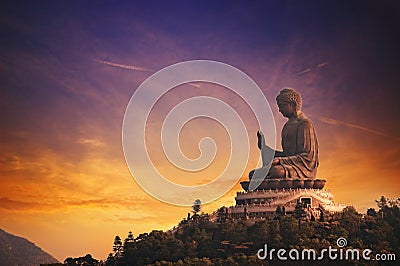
[275,113,319,179]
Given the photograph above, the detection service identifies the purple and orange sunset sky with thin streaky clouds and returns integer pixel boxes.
[0,1,400,261]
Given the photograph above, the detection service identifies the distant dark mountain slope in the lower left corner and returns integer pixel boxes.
[0,229,58,266]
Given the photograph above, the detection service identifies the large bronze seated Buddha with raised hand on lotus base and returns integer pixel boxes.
[242,88,325,190]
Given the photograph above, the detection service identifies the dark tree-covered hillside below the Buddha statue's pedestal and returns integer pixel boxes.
[104,197,400,266]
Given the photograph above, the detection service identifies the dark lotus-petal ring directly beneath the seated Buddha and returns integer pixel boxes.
[240,178,326,191]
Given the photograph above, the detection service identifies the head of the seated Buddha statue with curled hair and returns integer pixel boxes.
[276,88,301,117]
